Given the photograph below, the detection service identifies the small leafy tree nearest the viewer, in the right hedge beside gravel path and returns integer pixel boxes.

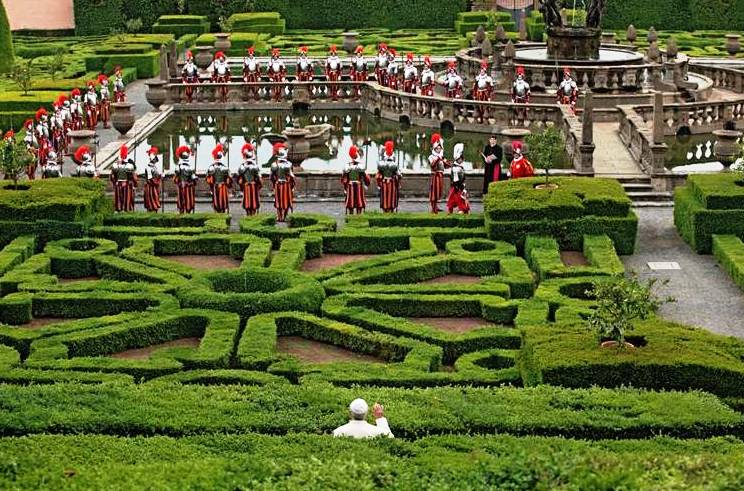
[586,274,674,349]
